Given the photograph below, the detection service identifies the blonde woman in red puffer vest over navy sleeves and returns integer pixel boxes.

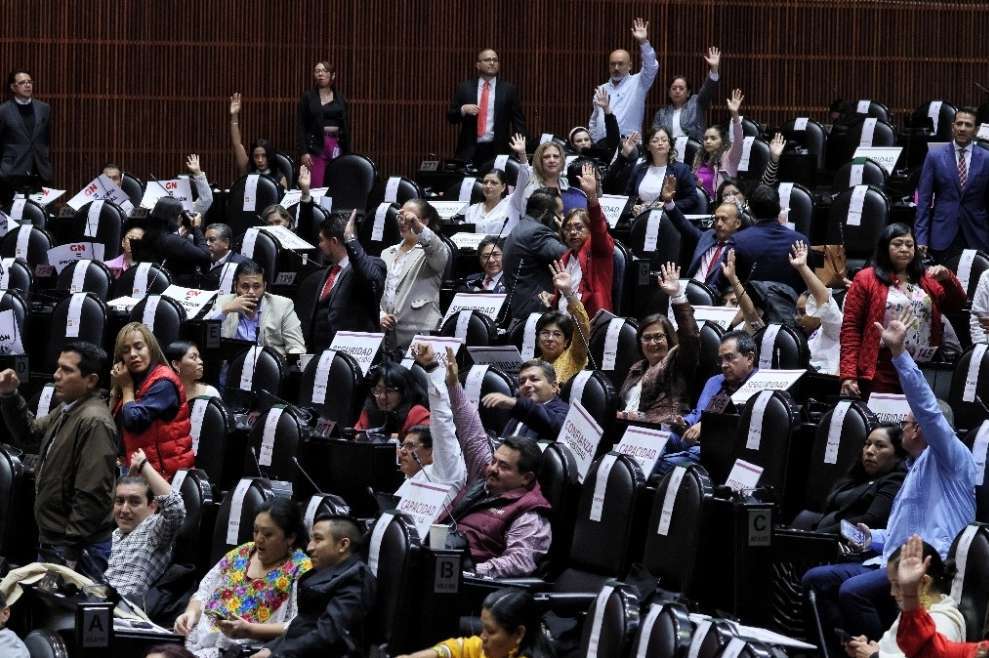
[110,322,196,482]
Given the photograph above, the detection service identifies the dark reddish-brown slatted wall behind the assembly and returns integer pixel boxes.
[0,0,989,190]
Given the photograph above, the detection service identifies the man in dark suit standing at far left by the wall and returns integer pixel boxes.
[0,69,52,205]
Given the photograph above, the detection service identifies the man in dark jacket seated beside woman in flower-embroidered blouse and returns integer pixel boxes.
[251,514,377,658]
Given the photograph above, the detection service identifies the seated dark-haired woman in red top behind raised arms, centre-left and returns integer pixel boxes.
[354,361,429,440]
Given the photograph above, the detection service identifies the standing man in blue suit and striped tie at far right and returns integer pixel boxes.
[915,108,989,261]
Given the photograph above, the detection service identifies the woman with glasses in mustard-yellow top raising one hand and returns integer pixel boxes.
[536,261,591,387]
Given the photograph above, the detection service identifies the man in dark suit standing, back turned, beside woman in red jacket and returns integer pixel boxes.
[505,189,567,322]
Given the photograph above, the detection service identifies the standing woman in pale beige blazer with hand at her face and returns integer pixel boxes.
[381,199,450,352]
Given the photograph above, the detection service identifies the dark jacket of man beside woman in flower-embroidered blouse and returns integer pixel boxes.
[265,556,376,658]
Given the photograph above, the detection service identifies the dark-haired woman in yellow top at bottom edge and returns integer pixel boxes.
[399,589,556,658]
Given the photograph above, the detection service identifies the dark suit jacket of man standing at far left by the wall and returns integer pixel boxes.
[0,99,52,181]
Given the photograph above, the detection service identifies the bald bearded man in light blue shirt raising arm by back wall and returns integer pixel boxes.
[587,18,659,143]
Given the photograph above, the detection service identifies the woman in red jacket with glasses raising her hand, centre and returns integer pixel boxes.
[560,163,615,318]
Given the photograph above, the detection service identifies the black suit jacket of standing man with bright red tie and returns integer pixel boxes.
[446,78,528,160]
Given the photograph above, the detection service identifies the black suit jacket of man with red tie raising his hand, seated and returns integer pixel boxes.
[296,234,387,354]
